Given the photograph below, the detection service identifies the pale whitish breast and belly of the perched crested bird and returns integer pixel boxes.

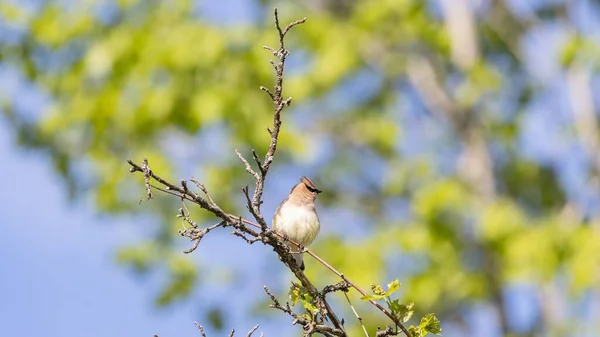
[273,204,321,246]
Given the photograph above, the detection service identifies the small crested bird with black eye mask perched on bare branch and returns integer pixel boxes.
[273,177,321,270]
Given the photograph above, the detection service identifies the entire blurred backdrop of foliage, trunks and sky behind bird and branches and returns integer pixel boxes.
[0,0,600,337]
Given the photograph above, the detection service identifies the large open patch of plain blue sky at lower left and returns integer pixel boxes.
[0,117,198,337]
